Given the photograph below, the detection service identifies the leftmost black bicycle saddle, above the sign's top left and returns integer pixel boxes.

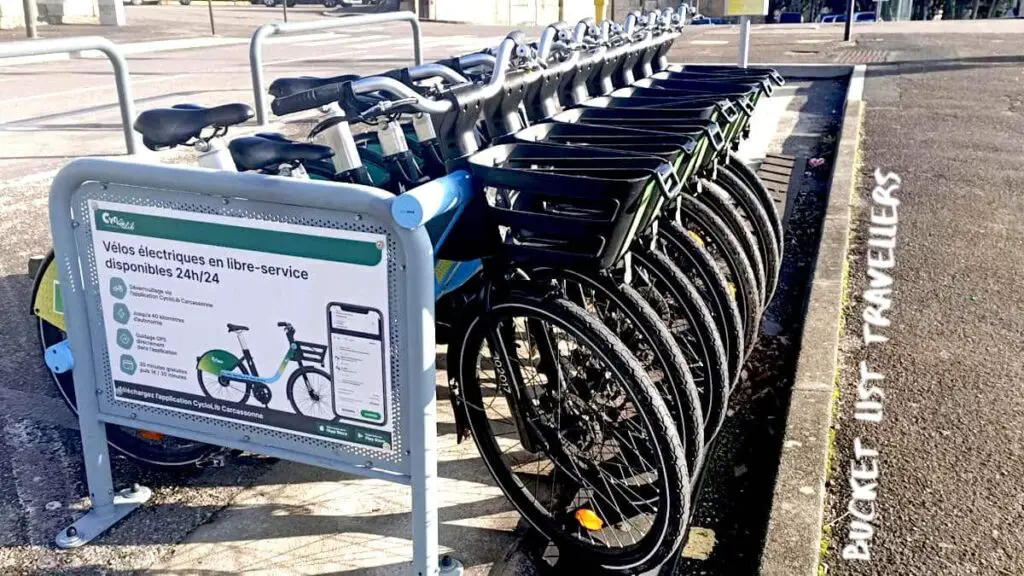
[132,104,256,150]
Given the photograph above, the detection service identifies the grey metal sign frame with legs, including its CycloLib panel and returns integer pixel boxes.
[47,159,450,576]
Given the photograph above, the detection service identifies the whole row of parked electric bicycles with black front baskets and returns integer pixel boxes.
[34,6,782,573]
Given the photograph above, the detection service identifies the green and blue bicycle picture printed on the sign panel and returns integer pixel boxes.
[196,322,335,420]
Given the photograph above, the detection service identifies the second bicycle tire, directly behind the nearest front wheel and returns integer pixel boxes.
[529,269,705,480]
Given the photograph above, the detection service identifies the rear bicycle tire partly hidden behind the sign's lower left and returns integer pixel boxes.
[37,317,222,469]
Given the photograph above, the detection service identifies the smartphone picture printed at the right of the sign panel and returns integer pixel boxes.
[327,302,388,426]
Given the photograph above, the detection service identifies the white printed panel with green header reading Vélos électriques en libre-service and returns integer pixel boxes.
[90,201,395,451]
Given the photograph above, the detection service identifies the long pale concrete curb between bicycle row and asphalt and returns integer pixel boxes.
[761,65,866,576]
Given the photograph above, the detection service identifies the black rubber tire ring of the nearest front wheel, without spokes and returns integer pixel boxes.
[449,290,690,573]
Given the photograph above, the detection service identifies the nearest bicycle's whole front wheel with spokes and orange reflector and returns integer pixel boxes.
[449,291,690,572]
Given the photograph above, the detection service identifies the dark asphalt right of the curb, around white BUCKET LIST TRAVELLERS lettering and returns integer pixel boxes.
[825,26,1024,576]
